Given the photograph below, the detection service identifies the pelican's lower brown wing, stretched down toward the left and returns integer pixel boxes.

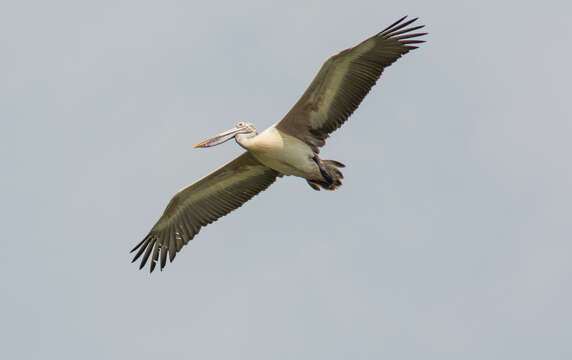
[131,152,278,271]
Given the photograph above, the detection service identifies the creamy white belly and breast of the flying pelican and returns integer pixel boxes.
[247,127,321,179]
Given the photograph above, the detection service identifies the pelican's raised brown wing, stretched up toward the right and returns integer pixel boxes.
[276,17,426,153]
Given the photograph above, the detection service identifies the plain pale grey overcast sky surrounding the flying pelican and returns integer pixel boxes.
[0,0,572,360]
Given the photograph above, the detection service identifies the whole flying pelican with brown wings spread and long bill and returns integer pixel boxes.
[131,16,427,272]
